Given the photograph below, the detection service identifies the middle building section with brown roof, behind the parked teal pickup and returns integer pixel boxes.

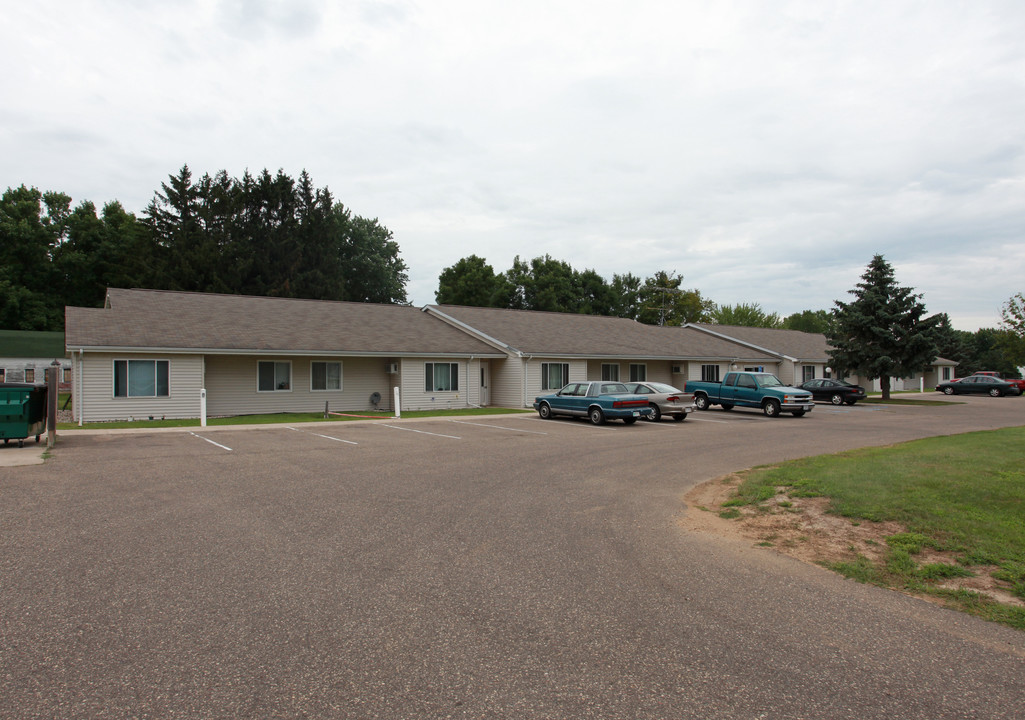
[423,305,779,407]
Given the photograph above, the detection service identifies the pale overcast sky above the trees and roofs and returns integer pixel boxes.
[0,0,1025,330]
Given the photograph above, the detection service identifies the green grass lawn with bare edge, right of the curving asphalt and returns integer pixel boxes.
[724,428,1025,630]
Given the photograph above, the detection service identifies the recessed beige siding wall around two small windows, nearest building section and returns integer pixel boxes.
[206,355,398,415]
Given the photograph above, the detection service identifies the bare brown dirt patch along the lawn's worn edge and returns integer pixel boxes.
[680,474,1025,607]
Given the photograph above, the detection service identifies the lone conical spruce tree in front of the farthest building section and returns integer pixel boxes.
[826,254,939,400]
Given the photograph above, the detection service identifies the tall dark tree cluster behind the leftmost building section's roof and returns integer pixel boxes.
[0,165,408,330]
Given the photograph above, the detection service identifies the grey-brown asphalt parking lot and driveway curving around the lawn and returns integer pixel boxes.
[6,396,1025,718]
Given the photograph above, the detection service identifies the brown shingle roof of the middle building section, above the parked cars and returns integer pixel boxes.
[427,305,766,360]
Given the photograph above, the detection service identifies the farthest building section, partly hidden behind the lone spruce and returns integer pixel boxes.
[686,323,957,392]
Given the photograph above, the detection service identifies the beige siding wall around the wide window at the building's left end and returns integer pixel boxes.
[74,353,203,423]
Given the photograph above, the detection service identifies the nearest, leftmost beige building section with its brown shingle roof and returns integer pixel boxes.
[66,288,505,423]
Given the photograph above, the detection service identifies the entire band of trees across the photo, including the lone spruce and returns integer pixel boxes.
[0,171,1025,377]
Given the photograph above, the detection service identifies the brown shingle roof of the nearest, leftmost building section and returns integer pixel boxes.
[66,288,497,356]
